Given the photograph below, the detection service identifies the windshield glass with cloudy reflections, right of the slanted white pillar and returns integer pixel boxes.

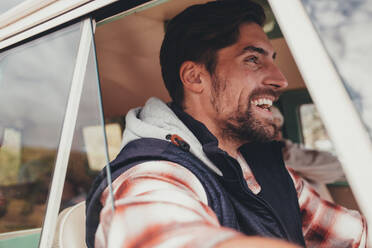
[302,0,372,137]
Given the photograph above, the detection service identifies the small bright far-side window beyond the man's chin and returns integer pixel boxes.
[300,104,335,154]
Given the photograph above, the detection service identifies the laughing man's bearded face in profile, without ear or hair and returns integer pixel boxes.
[203,23,287,142]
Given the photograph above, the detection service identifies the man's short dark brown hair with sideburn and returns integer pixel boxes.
[160,0,265,106]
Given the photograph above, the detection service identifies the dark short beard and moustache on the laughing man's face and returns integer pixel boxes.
[211,75,280,143]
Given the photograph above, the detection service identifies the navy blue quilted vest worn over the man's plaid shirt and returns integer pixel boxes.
[86,106,305,247]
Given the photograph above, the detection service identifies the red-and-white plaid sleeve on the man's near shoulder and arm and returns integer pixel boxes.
[95,161,241,247]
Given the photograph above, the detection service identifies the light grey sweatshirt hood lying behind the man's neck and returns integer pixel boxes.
[122,97,222,176]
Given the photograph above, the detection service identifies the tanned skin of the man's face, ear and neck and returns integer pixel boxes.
[180,23,288,157]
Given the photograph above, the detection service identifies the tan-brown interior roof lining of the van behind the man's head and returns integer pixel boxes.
[95,0,305,118]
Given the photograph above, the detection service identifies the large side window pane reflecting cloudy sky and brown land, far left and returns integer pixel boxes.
[0,24,80,233]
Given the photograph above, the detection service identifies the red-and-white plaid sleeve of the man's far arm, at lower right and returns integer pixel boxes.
[288,168,367,248]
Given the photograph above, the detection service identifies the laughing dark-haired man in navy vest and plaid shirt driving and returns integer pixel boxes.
[87,0,366,247]
